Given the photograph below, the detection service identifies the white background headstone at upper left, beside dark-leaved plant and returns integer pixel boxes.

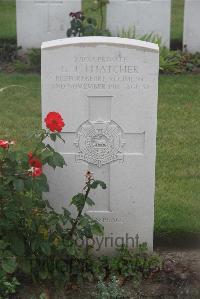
[16,0,81,49]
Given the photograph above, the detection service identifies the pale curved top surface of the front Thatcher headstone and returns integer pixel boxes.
[41,36,159,52]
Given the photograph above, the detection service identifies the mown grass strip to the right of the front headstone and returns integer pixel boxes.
[155,75,200,234]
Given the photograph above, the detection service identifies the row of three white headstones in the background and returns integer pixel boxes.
[16,0,200,52]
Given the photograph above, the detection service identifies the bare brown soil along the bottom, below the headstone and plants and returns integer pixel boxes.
[12,249,200,299]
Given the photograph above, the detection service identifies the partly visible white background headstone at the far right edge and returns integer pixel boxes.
[183,0,200,53]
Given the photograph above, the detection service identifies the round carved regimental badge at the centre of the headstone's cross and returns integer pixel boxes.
[74,121,125,167]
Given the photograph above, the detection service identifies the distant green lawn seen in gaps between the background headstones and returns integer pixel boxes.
[0,0,184,47]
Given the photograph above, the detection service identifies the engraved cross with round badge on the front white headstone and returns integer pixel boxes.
[74,96,145,213]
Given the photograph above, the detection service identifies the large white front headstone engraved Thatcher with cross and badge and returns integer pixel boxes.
[42,37,159,252]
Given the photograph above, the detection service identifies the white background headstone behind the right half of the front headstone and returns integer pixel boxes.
[107,0,171,48]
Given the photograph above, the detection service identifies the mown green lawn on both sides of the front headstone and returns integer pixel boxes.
[0,74,200,235]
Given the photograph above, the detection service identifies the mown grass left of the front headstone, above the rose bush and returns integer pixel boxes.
[0,74,41,147]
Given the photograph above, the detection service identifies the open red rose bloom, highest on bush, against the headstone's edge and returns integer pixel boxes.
[44,112,65,132]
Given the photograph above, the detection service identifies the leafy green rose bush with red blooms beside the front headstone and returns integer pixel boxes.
[0,112,106,295]
